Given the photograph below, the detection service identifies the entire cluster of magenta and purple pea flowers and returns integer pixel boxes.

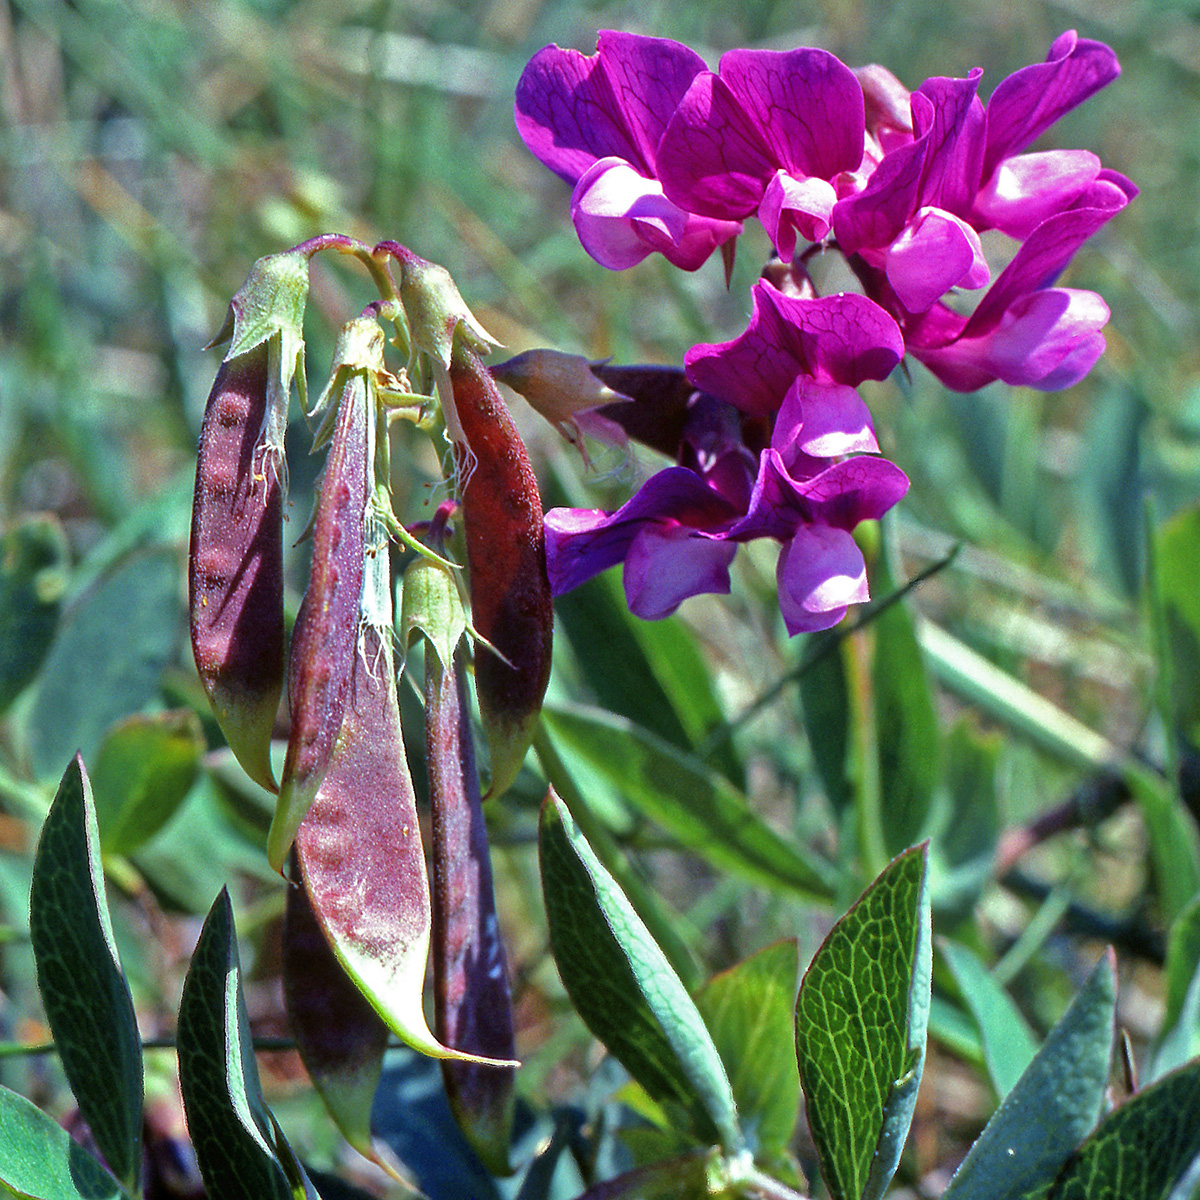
[515,31,1136,634]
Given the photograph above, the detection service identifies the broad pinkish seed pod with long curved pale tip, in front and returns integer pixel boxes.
[295,624,515,1066]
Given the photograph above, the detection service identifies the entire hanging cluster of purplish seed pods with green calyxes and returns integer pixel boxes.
[190,235,552,1170]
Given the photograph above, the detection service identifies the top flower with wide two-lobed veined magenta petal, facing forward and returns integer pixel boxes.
[658,49,864,260]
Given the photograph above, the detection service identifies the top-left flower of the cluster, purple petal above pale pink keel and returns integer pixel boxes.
[514,30,742,271]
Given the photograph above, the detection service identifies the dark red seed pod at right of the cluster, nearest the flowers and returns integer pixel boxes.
[450,343,554,796]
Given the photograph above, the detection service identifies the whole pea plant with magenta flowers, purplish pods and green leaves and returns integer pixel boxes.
[0,21,1200,1200]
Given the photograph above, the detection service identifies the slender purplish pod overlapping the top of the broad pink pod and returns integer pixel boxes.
[266,371,374,871]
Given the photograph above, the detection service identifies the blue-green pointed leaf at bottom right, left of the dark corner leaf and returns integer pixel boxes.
[943,950,1116,1200]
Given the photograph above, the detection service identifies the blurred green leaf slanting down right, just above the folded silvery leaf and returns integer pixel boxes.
[542,707,834,899]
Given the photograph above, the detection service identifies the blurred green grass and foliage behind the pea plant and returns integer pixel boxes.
[0,0,1200,1195]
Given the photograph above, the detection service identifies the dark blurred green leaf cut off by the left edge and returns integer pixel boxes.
[0,515,70,713]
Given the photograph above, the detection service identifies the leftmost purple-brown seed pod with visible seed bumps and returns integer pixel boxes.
[188,341,287,791]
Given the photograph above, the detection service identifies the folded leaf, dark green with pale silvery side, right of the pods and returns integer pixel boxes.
[539,790,743,1153]
